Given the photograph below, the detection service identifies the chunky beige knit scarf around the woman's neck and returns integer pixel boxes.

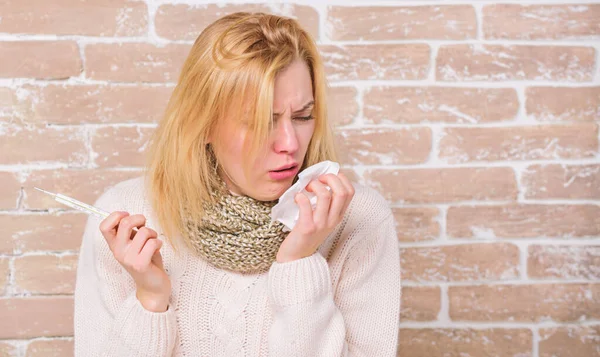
[184,170,289,273]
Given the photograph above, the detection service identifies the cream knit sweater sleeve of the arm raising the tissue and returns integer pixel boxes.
[269,197,401,357]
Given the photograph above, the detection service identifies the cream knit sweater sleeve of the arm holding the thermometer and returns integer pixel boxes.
[74,188,177,357]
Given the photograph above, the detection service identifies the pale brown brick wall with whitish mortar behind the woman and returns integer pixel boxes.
[0,0,600,357]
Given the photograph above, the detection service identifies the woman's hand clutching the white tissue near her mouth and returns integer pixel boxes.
[277,173,354,263]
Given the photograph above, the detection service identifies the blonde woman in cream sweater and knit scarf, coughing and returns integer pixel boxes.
[75,13,400,357]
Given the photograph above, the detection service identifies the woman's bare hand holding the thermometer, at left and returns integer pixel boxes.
[100,211,171,312]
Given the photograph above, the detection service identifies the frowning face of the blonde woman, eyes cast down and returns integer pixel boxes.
[212,60,315,201]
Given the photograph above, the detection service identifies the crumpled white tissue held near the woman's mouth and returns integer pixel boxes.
[271,161,340,231]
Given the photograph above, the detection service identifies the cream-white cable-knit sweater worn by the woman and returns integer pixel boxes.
[74,177,400,357]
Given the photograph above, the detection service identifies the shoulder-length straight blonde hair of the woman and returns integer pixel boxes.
[145,12,336,250]
